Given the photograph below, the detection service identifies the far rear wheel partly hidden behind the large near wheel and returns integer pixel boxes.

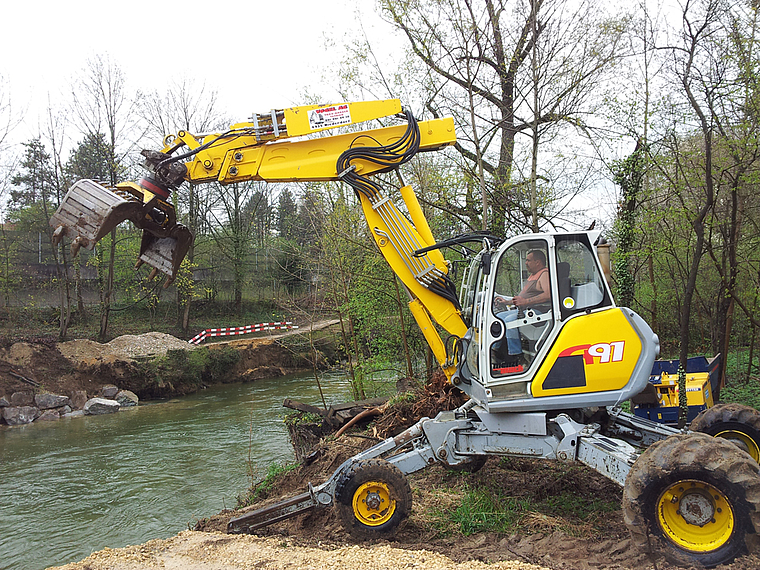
[691,403,760,463]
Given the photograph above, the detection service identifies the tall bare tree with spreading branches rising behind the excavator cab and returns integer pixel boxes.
[381,0,625,234]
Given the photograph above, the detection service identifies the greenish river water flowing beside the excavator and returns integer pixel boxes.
[0,375,350,570]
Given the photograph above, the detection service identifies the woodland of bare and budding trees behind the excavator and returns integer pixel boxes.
[0,0,760,405]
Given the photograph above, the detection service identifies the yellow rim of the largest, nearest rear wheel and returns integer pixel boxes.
[657,480,734,552]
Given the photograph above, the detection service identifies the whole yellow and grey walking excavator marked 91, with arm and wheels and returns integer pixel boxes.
[50,99,760,567]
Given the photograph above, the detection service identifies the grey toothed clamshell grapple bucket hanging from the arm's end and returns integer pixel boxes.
[50,180,193,287]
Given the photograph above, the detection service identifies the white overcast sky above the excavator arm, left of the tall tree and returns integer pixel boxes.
[0,0,400,149]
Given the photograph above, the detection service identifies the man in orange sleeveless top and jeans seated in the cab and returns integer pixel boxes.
[493,249,551,357]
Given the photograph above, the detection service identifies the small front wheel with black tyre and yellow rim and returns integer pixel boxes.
[335,459,412,539]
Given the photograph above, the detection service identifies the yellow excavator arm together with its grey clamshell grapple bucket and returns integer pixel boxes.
[50,99,466,377]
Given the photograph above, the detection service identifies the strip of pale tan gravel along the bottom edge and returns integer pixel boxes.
[47,531,544,570]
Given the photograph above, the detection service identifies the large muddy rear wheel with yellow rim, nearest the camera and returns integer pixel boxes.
[623,433,760,568]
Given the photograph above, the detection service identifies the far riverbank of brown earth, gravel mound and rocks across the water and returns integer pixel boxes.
[0,321,333,425]
